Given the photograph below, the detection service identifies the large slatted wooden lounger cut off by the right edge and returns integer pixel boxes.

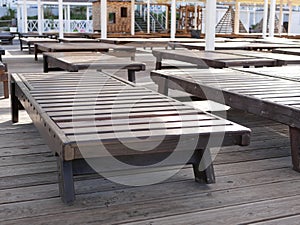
[151,67,300,172]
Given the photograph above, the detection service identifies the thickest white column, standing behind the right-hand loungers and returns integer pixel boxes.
[205,0,217,51]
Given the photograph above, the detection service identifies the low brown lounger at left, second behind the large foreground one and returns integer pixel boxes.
[34,43,136,61]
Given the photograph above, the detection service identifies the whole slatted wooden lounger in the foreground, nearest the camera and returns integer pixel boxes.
[11,72,250,203]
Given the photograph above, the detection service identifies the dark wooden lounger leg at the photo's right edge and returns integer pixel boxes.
[290,127,300,172]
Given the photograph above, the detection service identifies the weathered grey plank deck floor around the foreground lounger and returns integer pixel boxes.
[0,44,300,225]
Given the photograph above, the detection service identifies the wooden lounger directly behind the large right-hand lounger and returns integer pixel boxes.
[152,49,278,70]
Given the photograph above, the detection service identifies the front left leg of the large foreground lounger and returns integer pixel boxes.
[57,157,75,204]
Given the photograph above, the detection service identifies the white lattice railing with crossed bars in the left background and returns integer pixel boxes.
[23,19,93,32]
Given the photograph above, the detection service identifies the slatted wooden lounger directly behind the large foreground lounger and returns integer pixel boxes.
[43,52,146,82]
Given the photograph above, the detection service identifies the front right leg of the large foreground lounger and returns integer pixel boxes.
[192,150,216,184]
